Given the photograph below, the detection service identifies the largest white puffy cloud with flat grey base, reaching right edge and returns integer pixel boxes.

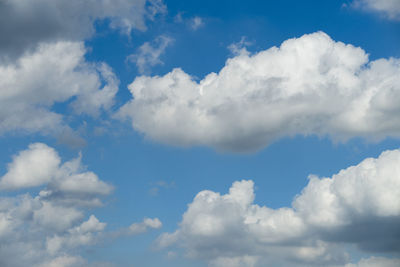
[119,32,400,152]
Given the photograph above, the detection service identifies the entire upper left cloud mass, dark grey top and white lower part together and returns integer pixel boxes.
[0,0,166,142]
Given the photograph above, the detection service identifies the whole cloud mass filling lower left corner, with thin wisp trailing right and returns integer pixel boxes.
[0,143,161,267]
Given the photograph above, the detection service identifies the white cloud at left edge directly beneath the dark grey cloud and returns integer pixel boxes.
[0,42,119,138]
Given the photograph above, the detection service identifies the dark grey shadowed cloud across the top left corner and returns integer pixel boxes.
[0,0,166,59]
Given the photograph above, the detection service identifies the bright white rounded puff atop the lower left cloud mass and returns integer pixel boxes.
[0,143,112,199]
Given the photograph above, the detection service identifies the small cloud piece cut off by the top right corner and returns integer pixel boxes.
[352,0,400,20]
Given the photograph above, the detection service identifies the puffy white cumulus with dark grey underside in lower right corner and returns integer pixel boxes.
[157,150,400,266]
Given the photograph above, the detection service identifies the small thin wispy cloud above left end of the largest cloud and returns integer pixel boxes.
[127,35,173,74]
